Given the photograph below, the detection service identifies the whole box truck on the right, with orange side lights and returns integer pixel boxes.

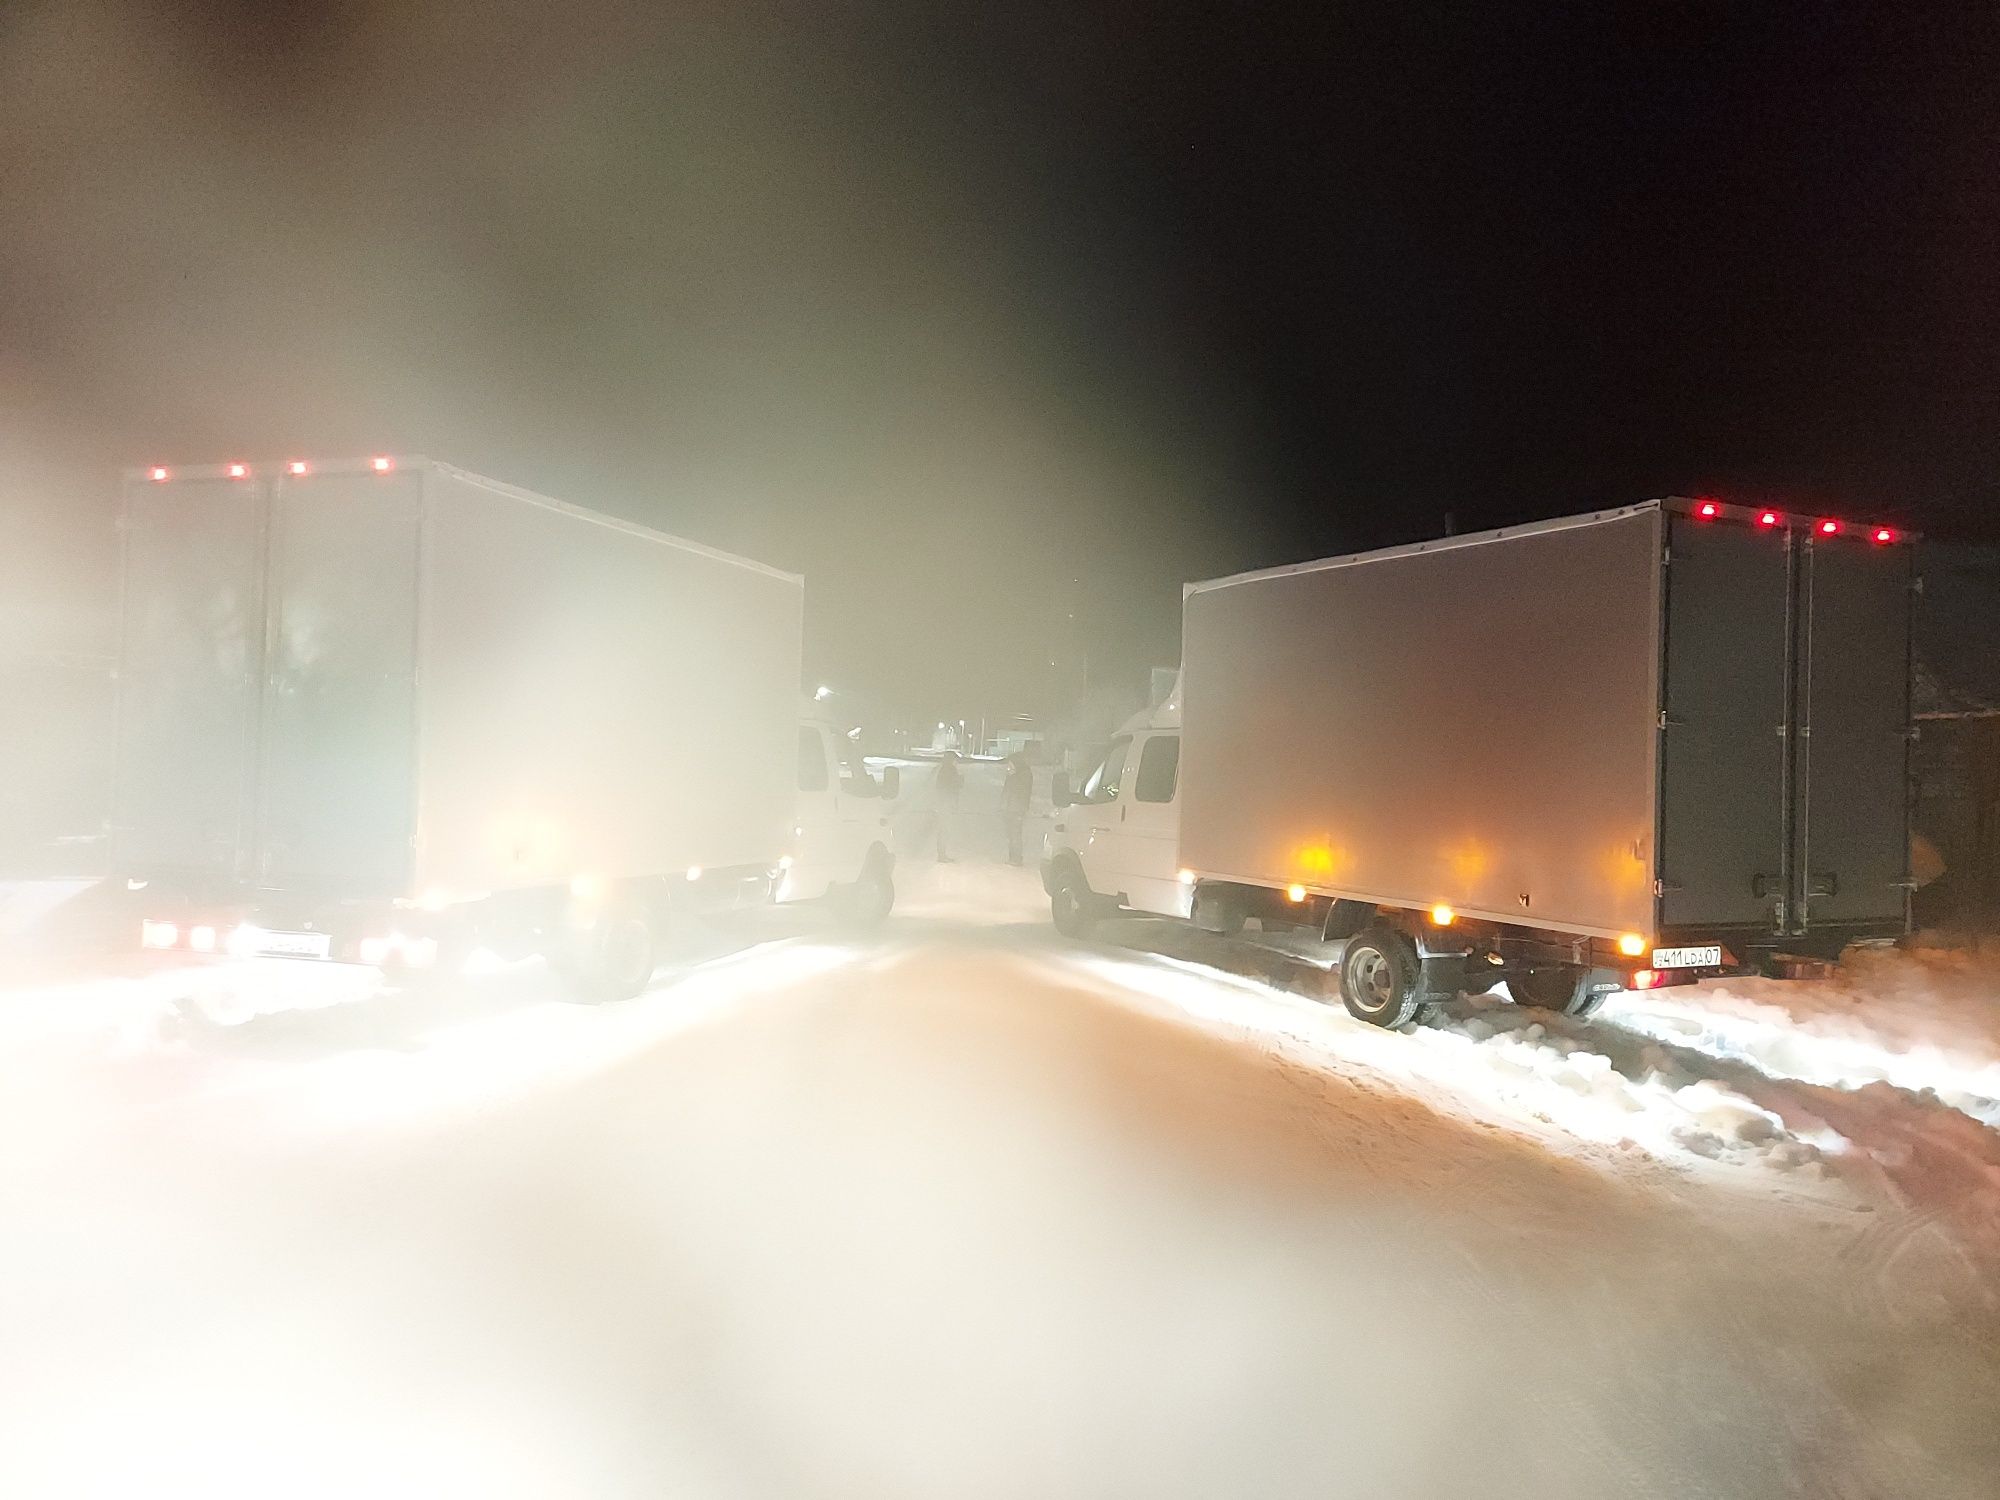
[1042,500,1914,1026]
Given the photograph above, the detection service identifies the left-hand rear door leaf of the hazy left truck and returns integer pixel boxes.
[112,480,264,880]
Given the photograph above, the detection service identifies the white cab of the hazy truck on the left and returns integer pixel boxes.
[776,714,900,926]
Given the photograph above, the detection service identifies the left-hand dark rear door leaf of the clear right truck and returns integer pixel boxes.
[1660,514,1790,928]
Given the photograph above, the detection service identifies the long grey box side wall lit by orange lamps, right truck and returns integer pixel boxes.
[1182,506,1660,936]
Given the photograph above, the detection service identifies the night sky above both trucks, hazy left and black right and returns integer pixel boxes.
[0,0,2000,714]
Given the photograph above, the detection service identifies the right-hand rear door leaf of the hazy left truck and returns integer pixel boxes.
[258,468,422,896]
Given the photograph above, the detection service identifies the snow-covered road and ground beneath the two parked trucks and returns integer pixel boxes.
[0,866,2000,1498]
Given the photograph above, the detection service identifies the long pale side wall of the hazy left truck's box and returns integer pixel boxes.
[416,466,804,892]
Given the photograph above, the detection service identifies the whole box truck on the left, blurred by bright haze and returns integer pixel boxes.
[112,456,894,996]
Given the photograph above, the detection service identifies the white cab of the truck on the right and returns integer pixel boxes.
[1042,686,1194,936]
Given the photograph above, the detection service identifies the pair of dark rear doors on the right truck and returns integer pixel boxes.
[1660,514,1912,936]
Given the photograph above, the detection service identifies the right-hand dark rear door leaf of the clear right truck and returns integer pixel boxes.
[1798,536,1914,932]
